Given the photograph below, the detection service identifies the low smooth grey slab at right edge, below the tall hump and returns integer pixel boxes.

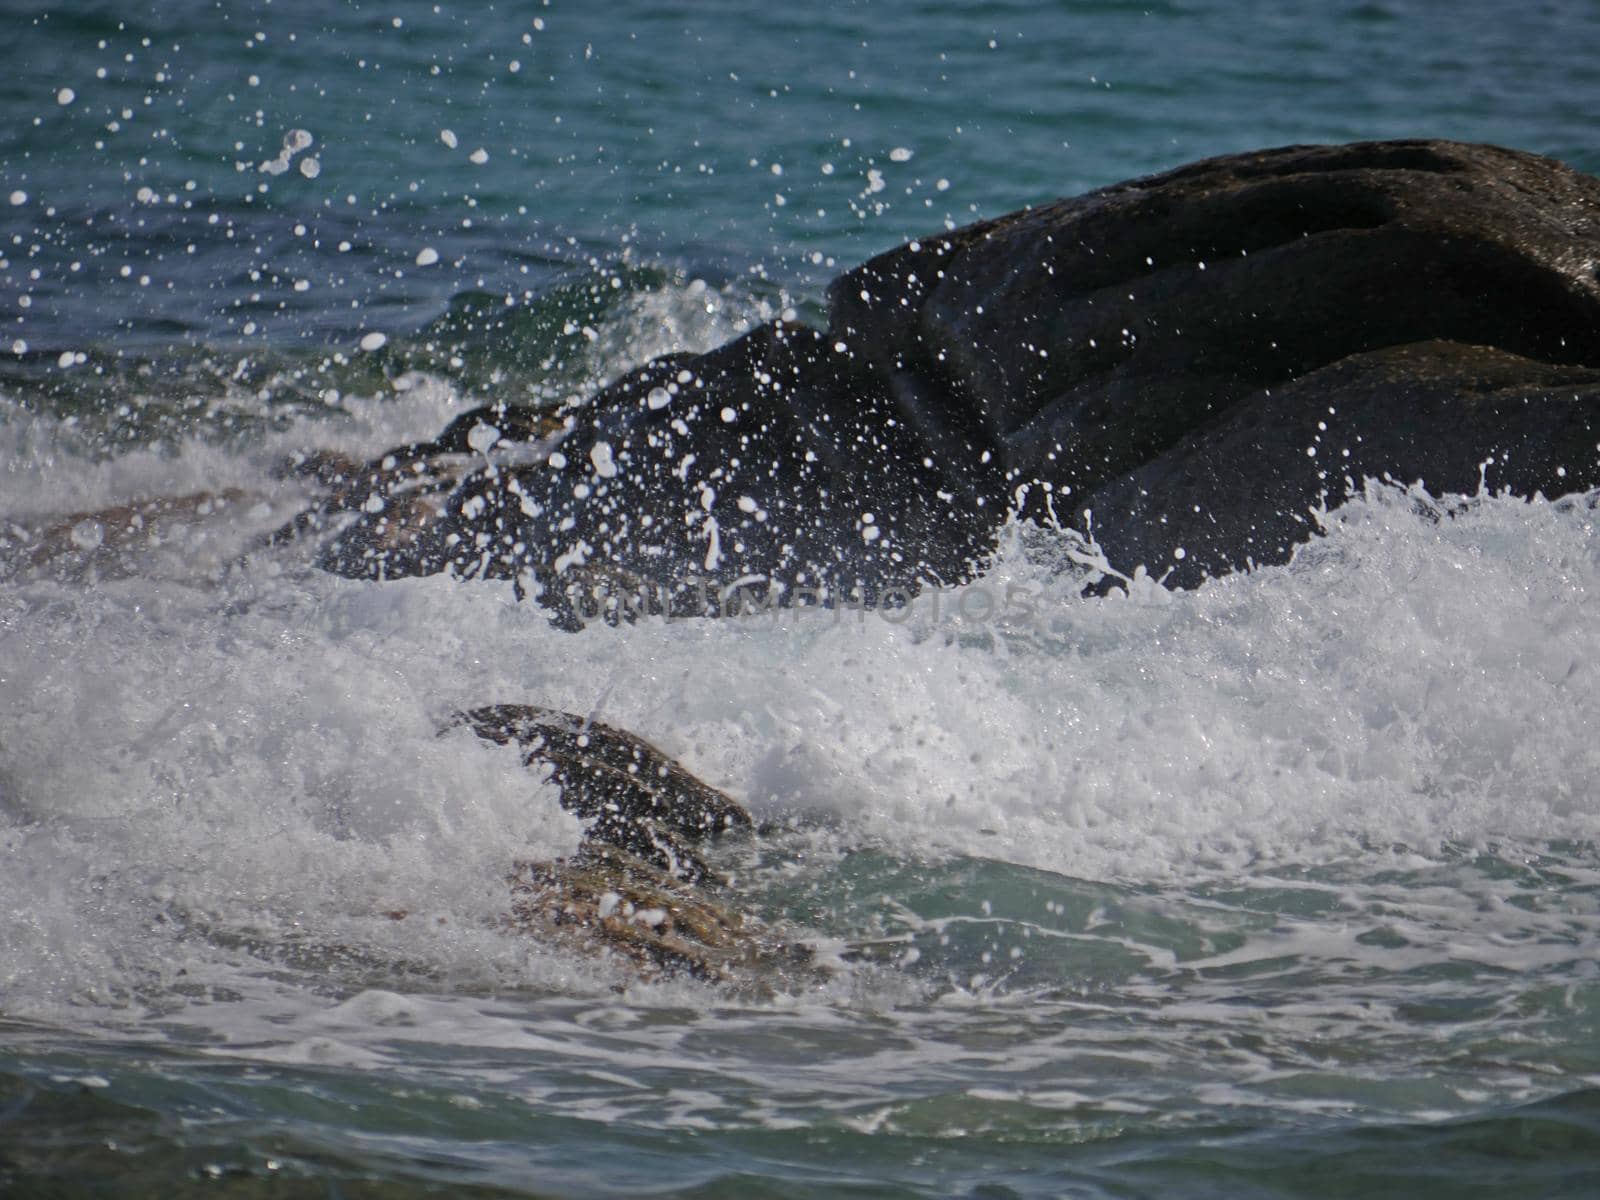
[1091,341,1600,587]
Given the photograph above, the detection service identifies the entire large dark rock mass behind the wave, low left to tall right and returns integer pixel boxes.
[284,141,1600,618]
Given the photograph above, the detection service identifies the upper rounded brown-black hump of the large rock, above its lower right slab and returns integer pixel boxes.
[830,142,1600,521]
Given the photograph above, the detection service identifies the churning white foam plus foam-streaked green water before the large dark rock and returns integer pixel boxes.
[0,307,1600,1187]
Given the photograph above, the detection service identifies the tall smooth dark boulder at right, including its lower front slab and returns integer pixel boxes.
[830,141,1600,584]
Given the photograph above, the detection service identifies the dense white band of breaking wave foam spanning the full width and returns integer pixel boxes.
[0,425,1600,1036]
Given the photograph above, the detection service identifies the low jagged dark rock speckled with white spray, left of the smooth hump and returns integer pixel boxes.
[293,323,1005,618]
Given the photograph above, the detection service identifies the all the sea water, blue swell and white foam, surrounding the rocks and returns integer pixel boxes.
[0,0,1600,1197]
